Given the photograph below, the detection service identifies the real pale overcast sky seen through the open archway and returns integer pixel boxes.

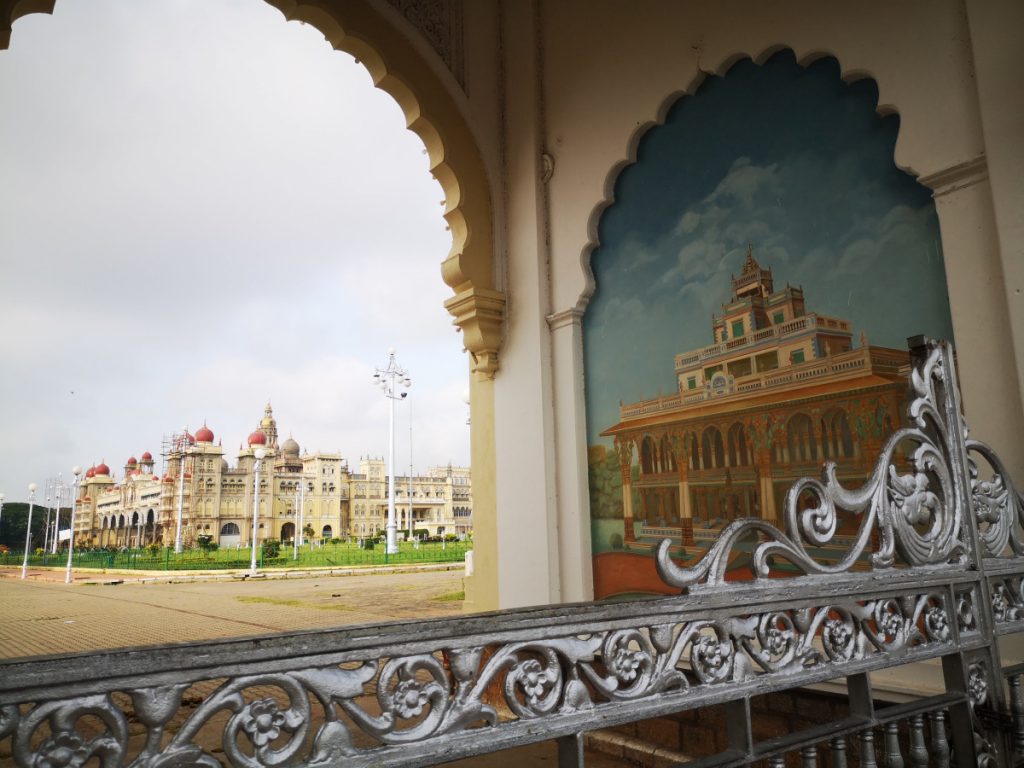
[0,0,469,500]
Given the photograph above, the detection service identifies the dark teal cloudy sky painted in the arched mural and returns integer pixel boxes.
[584,52,952,444]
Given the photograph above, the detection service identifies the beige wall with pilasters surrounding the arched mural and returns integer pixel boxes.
[475,0,1024,606]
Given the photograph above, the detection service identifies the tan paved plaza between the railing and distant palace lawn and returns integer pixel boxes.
[0,567,464,658]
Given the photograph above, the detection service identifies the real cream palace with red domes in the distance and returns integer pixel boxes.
[75,404,473,547]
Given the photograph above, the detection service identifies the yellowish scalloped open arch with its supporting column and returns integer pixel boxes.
[0,0,506,610]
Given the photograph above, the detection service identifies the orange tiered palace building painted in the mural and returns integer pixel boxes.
[601,249,909,544]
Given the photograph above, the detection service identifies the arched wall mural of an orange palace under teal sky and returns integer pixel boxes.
[584,53,952,597]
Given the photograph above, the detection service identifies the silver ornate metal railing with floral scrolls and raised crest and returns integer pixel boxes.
[0,342,1024,768]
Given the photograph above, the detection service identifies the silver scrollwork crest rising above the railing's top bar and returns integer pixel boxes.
[657,344,966,588]
